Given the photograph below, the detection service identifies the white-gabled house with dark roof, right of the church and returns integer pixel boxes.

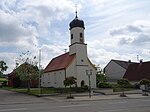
[104,59,134,83]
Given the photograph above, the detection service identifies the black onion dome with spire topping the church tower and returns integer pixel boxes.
[69,12,85,30]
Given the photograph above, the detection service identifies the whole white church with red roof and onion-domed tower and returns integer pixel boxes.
[41,11,96,88]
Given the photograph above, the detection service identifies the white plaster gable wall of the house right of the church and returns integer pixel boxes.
[105,61,126,82]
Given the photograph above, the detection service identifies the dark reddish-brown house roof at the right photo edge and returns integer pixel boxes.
[123,61,150,81]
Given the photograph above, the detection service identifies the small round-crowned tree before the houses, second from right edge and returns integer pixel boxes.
[117,78,130,97]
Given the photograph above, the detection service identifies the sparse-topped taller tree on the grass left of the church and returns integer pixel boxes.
[15,51,39,92]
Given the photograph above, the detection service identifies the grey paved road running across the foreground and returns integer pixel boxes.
[0,90,150,112]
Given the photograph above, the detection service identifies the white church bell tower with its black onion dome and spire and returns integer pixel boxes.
[69,11,87,65]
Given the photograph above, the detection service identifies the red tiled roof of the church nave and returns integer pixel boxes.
[44,52,75,73]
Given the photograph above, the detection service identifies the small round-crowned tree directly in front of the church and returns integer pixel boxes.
[64,76,76,98]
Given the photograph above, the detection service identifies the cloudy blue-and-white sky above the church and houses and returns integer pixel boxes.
[0,0,150,73]
